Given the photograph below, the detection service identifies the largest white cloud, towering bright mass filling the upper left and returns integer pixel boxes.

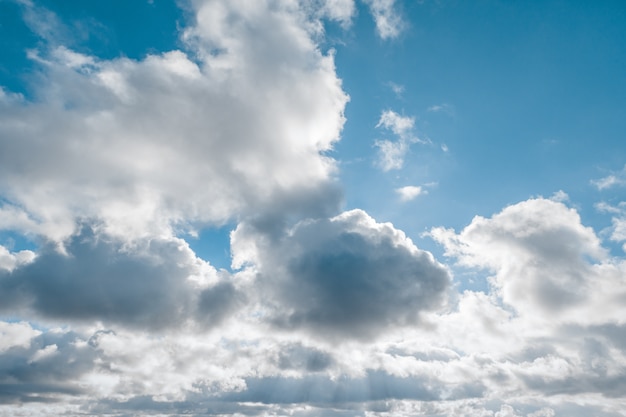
[0,1,348,242]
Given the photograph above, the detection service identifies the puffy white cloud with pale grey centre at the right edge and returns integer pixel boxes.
[431,198,626,324]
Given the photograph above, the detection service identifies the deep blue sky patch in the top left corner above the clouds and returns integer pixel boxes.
[0,0,187,98]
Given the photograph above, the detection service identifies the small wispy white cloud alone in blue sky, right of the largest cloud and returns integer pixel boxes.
[374,110,425,171]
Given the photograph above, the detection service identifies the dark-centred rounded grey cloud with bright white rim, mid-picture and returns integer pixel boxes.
[232,210,450,338]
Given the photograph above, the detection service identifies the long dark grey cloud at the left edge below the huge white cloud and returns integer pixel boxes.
[0,224,241,329]
